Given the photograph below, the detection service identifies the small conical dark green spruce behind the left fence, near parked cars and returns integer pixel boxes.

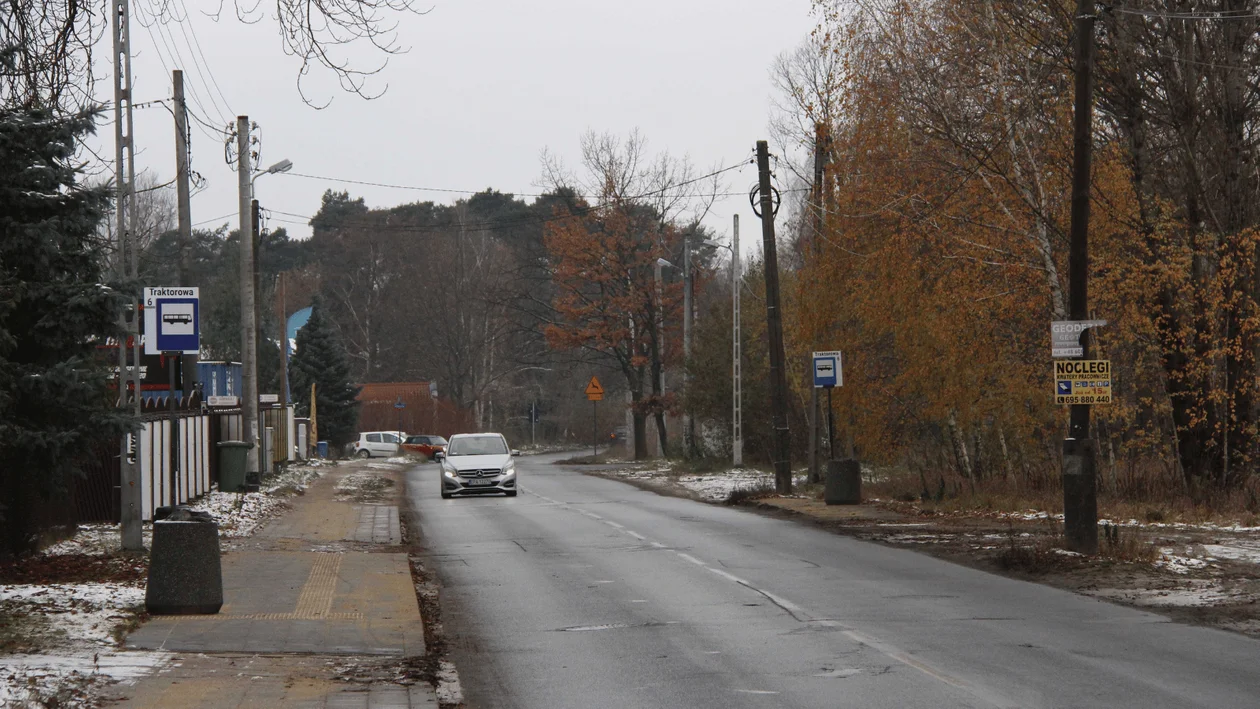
[289,298,359,446]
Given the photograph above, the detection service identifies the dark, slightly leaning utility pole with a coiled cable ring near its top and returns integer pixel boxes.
[757,140,791,495]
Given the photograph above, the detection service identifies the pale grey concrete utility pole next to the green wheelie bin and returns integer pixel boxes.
[237,116,262,475]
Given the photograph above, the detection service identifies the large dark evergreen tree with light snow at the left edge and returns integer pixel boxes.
[0,110,132,554]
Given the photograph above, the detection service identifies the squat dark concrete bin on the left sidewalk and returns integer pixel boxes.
[145,508,223,616]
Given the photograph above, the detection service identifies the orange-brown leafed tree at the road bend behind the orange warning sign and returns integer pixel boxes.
[544,200,682,458]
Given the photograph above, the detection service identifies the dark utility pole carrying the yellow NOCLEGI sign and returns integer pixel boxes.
[1063,0,1099,554]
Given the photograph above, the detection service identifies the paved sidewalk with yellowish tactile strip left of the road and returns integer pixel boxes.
[118,461,437,709]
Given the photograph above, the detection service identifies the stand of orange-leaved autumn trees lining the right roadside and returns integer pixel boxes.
[789,0,1260,492]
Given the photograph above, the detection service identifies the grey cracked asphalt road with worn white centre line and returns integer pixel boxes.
[407,456,1260,709]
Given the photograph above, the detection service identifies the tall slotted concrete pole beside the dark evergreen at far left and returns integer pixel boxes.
[112,0,145,552]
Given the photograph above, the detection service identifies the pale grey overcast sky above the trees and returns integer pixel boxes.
[88,0,815,244]
